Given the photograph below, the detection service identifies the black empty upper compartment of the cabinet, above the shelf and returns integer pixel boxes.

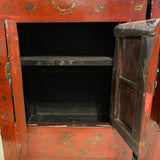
[18,23,117,57]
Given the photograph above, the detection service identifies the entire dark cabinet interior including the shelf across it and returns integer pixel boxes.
[18,23,116,123]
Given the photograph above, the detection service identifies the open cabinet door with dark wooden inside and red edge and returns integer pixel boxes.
[110,19,160,157]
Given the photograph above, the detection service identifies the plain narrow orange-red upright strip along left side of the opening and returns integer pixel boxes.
[5,21,27,155]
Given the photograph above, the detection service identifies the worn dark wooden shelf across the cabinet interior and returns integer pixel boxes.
[21,56,113,66]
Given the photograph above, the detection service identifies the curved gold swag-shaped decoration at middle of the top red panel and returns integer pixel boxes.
[52,0,78,15]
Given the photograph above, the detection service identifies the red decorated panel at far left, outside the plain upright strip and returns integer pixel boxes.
[0,21,19,160]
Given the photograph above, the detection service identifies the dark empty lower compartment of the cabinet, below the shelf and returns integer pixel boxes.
[23,67,112,122]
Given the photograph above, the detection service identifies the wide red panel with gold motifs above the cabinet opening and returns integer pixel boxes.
[0,0,147,22]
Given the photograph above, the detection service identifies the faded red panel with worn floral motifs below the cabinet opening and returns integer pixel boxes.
[25,125,132,160]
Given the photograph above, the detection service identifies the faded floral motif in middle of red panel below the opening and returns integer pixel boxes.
[58,131,75,152]
